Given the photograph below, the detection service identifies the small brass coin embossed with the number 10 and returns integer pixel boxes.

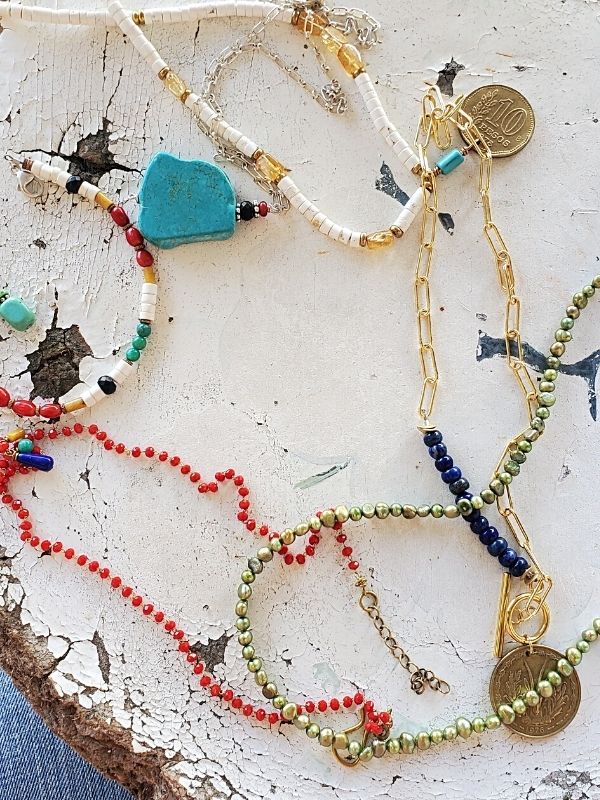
[462,84,535,158]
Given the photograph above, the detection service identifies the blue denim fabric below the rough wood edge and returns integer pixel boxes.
[0,672,132,800]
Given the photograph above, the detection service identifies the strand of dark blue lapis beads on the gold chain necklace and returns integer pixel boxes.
[423,431,529,578]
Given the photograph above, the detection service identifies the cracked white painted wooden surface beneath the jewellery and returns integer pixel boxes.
[0,0,600,800]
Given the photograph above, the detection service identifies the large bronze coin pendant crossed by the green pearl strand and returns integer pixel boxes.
[490,644,581,739]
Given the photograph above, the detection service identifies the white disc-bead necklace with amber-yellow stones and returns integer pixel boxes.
[0,0,458,250]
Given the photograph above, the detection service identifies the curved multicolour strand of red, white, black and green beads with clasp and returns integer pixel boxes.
[0,155,158,424]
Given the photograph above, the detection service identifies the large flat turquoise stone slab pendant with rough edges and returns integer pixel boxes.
[138,153,236,249]
